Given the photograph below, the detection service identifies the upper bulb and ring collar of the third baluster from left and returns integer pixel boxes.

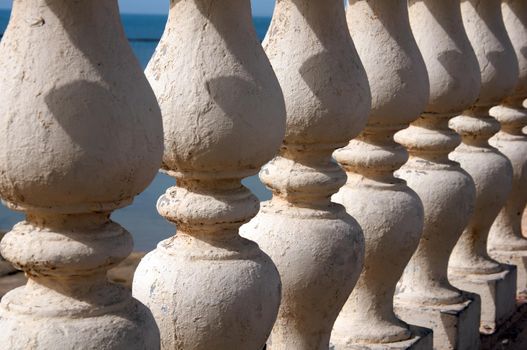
[260,0,371,207]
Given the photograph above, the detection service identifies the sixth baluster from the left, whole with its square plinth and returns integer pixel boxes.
[449,0,518,333]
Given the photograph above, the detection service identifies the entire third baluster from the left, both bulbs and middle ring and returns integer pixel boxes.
[242,0,370,350]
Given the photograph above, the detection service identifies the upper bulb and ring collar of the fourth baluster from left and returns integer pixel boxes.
[334,0,429,182]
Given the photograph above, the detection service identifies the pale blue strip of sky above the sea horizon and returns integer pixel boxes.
[0,0,274,16]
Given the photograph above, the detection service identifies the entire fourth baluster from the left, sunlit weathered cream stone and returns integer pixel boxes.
[331,0,432,349]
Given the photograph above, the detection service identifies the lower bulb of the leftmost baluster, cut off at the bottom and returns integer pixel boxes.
[0,286,159,350]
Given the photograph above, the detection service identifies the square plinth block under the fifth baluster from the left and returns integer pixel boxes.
[394,293,481,350]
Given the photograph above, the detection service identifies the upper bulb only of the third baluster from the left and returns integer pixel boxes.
[264,0,371,150]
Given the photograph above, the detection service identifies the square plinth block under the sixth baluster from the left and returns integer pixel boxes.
[448,265,516,334]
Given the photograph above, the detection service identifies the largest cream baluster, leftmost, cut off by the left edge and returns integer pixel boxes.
[0,0,163,350]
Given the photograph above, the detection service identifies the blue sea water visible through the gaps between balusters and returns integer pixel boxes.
[0,10,271,251]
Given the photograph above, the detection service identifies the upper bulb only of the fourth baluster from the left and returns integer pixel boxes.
[347,0,429,126]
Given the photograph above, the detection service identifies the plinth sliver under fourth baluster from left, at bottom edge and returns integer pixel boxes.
[329,326,433,350]
